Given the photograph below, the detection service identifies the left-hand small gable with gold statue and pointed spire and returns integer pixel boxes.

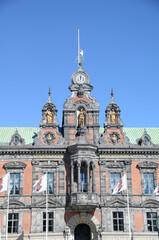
[33,88,64,145]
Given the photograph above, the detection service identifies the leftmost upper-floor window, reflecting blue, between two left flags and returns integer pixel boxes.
[10,173,20,195]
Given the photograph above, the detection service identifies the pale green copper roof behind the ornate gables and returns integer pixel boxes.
[0,127,159,144]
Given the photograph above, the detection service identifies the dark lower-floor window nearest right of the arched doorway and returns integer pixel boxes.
[113,212,124,232]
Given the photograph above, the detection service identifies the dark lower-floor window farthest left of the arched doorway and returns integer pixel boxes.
[8,213,19,233]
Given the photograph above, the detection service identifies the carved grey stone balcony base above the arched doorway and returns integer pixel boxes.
[69,192,99,211]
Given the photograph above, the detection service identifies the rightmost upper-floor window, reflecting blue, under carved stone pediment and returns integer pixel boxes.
[143,173,154,194]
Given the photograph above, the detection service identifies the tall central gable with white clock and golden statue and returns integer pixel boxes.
[63,63,99,144]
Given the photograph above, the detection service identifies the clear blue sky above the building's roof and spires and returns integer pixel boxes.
[0,0,159,127]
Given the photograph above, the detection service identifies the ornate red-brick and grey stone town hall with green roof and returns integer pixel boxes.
[0,53,159,240]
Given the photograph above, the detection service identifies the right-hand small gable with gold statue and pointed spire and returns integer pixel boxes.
[99,89,130,145]
